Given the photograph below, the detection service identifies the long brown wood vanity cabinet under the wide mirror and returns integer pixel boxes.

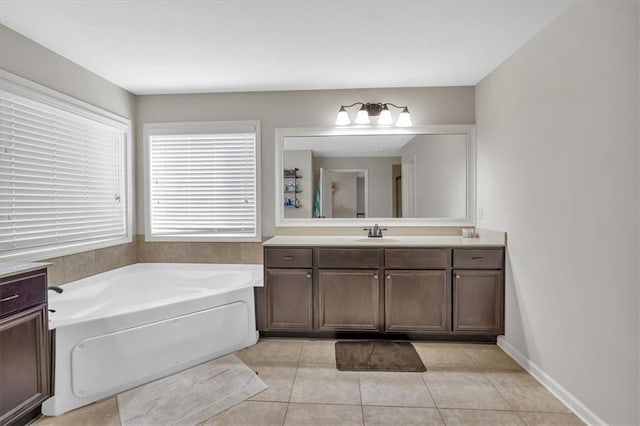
[256,246,504,341]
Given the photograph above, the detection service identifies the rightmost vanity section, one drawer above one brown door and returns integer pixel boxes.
[453,249,504,335]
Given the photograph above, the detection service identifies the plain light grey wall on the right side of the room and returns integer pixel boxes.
[476,0,640,425]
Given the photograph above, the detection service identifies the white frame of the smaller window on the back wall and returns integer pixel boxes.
[142,120,262,242]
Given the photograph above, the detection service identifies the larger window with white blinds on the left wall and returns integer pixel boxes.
[0,73,131,260]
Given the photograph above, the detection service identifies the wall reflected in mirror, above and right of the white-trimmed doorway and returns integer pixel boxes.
[314,157,400,218]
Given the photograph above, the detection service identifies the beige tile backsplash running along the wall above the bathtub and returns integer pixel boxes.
[46,235,262,285]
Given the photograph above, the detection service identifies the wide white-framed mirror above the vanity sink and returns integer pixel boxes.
[276,125,475,226]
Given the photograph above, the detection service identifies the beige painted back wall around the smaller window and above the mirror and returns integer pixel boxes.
[137,87,475,236]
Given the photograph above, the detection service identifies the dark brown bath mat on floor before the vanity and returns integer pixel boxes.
[336,341,427,371]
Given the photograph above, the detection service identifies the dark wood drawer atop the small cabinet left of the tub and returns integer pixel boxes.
[0,270,47,316]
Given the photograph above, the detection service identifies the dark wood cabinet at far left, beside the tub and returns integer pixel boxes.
[0,269,50,425]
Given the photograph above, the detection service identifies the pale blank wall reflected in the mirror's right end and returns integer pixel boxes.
[401,135,467,218]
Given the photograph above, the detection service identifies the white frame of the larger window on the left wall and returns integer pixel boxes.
[0,70,133,262]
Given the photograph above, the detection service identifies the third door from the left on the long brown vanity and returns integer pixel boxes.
[385,271,451,333]
